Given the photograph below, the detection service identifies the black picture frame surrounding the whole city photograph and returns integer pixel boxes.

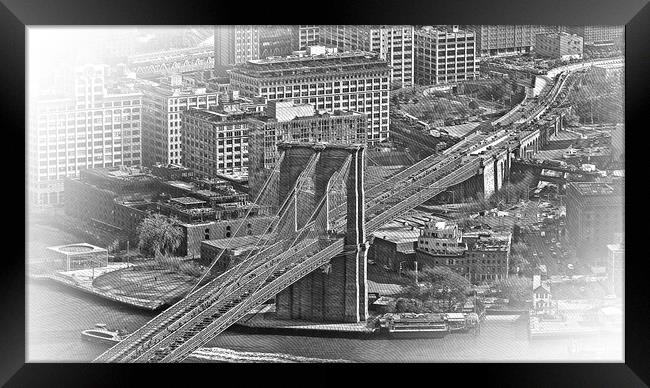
[0,0,650,387]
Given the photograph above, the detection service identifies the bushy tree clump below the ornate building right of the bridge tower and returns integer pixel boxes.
[404,266,472,308]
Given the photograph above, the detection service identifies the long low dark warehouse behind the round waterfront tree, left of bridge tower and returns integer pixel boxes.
[65,164,273,257]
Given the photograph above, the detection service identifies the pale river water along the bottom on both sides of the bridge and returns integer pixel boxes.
[26,281,623,362]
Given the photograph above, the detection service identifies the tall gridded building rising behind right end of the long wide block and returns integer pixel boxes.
[320,25,415,88]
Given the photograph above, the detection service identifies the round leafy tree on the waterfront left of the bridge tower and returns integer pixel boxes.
[137,214,183,257]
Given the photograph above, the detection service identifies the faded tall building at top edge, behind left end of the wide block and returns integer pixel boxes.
[214,25,294,74]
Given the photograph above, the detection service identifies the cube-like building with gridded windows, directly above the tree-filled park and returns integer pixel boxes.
[415,26,478,85]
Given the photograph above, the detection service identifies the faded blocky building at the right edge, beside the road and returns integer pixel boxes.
[566,182,624,259]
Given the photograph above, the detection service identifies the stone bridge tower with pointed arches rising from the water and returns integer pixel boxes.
[276,142,368,322]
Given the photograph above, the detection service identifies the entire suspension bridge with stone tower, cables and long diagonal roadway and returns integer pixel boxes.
[95,57,620,362]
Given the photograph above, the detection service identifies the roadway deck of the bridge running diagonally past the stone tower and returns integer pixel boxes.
[95,59,596,362]
